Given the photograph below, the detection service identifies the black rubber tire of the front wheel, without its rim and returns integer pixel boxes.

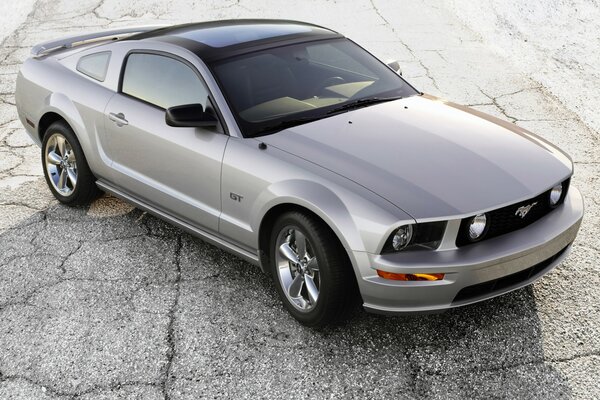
[269,211,357,328]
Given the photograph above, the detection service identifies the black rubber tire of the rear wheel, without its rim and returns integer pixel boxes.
[42,121,102,206]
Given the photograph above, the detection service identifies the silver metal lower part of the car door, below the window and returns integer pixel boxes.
[104,94,229,232]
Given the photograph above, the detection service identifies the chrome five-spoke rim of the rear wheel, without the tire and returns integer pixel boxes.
[44,133,77,197]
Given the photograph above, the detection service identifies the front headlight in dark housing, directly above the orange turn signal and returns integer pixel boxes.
[381,221,446,253]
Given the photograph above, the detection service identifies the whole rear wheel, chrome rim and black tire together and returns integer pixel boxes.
[42,121,101,205]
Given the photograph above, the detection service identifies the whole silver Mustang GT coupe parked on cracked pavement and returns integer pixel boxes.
[16,20,583,326]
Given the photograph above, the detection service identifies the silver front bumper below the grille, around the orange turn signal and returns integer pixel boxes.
[353,187,583,313]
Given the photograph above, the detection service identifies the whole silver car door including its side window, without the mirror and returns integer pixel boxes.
[105,53,229,233]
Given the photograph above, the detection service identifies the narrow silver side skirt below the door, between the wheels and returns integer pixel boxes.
[96,180,260,266]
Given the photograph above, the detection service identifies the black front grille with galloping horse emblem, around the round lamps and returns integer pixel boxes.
[456,179,569,247]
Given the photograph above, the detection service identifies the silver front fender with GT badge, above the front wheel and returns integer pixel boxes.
[220,138,414,251]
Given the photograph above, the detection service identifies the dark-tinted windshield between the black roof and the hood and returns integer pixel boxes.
[211,39,418,137]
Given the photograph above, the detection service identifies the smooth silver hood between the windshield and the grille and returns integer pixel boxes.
[261,96,572,221]
